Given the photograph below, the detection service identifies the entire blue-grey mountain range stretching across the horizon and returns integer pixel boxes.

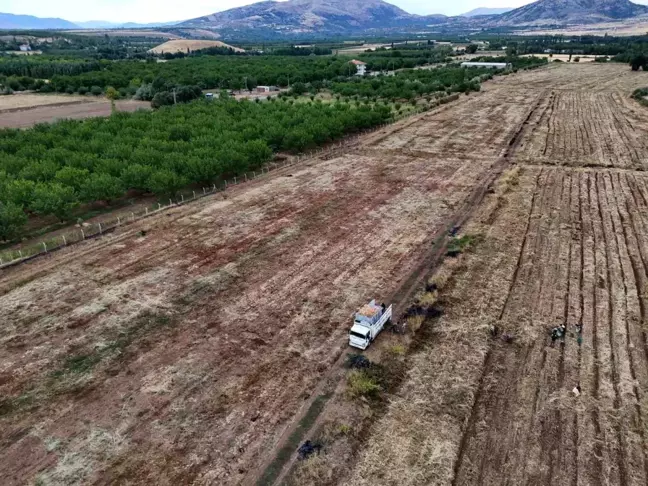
[0,0,648,32]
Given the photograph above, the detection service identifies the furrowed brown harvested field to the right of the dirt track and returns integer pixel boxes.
[340,66,648,486]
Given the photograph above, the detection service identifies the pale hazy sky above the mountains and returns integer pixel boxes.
[0,0,648,22]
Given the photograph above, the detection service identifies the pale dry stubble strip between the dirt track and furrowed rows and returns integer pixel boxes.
[346,164,531,486]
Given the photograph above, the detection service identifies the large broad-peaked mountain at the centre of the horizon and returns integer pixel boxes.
[180,0,446,34]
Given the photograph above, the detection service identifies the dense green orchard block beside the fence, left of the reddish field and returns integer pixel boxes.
[0,97,390,241]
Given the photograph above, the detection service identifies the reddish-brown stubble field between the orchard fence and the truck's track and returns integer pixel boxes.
[0,70,539,485]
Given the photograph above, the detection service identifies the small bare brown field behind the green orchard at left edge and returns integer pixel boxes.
[0,100,151,128]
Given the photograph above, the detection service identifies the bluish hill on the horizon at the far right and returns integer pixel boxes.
[495,0,648,26]
